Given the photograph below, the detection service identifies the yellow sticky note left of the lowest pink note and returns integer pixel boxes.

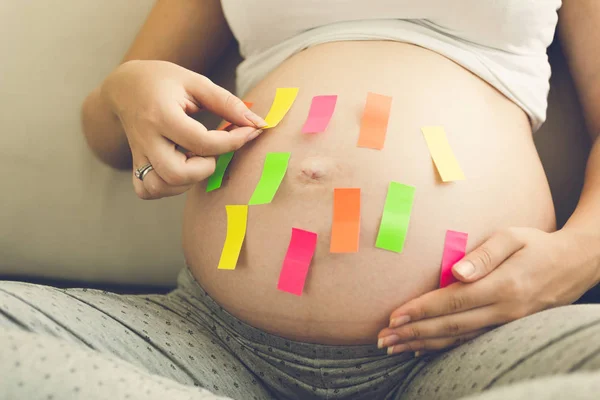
[218,205,248,269]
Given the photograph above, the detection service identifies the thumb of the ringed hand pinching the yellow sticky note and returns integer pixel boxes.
[186,72,267,128]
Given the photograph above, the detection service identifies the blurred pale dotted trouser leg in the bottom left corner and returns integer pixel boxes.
[0,328,230,400]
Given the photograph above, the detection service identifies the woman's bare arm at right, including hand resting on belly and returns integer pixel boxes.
[378,0,600,354]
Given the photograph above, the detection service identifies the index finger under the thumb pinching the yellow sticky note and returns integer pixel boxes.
[164,108,262,156]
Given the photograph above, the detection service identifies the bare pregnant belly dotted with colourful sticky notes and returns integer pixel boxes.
[183,42,554,344]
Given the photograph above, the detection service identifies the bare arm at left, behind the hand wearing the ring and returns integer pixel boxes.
[82,0,232,169]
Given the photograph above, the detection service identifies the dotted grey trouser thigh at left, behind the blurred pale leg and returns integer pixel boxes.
[0,282,269,399]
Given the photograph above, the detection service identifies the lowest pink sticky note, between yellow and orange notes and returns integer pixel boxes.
[277,228,317,296]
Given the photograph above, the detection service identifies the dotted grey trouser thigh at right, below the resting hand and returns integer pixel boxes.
[400,305,600,400]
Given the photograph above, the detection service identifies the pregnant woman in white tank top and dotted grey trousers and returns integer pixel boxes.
[0,0,600,400]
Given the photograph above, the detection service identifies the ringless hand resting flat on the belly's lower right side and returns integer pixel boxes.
[378,228,599,354]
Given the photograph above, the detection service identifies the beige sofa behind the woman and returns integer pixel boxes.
[0,0,589,285]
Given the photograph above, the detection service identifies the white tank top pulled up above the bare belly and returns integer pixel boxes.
[221,0,561,130]
